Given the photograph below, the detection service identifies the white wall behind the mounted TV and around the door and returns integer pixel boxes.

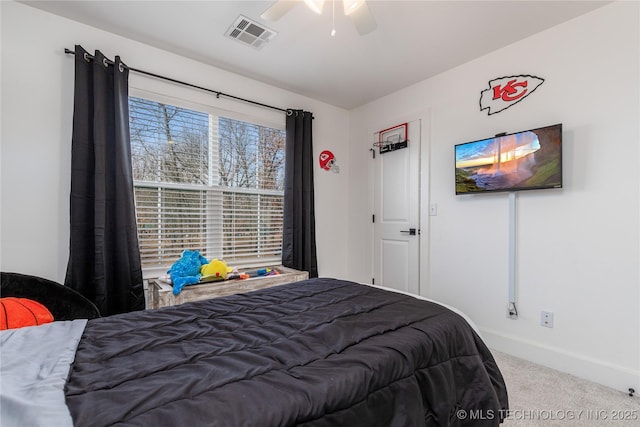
[349,2,640,390]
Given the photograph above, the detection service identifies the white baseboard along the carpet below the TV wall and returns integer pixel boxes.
[480,328,640,397]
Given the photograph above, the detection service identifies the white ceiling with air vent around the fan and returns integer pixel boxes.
[22,0,609,109]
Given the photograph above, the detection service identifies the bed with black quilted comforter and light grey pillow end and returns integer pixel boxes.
[0,278,508,427]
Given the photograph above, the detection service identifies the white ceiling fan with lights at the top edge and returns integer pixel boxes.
[260,0,378,36]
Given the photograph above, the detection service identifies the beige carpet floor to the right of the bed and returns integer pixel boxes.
[492,350,640,427]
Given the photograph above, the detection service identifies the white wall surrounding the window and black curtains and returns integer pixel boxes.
[0,1,349,282]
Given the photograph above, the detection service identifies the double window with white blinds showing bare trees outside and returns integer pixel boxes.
[129,97,285,269]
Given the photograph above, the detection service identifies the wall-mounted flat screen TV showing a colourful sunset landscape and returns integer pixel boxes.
[455,124,562,194]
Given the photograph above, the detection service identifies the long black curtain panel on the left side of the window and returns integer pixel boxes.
[65,45,145,316]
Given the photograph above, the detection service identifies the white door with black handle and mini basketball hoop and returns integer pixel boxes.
[373,120,421,294]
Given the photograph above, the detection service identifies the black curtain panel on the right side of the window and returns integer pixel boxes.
[282,110,318,277]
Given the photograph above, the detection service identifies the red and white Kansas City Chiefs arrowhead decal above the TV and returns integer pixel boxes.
[480,75,544,115]
